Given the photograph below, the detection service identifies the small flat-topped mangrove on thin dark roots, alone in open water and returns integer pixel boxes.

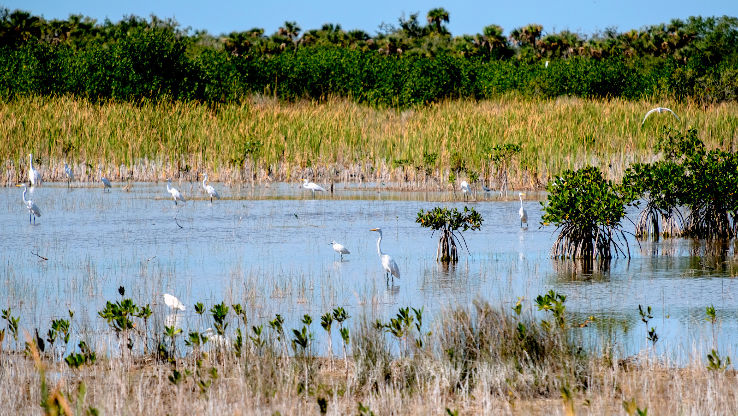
[415,206,484,263]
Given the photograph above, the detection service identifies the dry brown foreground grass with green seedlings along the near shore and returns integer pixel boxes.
[0,291,736,415]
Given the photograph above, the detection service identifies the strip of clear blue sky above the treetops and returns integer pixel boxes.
[2,0,738,36]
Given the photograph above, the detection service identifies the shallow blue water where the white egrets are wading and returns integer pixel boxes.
[0,182,738,361]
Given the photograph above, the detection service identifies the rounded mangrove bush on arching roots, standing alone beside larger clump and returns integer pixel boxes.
[542,167,634,260]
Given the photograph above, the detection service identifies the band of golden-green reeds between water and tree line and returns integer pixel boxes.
[0,95,738,189]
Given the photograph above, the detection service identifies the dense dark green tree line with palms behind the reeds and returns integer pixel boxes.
[0,9,738,107]
